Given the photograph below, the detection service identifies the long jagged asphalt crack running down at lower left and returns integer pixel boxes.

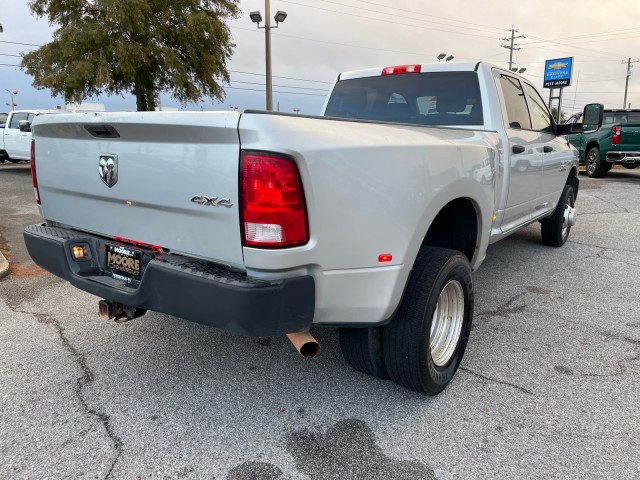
[12,308,123,480]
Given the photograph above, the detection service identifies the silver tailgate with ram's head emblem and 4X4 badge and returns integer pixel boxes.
[33,112,243,268]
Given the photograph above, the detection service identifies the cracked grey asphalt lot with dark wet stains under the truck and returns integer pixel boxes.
[0,164,640,480]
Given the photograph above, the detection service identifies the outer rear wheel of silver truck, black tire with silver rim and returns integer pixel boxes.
[384,247,473,395]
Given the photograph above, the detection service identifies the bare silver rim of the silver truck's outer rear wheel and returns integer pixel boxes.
[429,280,464,367]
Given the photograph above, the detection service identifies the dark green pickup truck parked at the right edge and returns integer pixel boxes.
[567,110,640,178]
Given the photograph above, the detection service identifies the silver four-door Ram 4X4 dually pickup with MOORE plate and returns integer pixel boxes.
[24,63,602,395]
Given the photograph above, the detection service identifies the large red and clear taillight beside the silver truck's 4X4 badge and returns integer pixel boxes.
[240,152,309,248]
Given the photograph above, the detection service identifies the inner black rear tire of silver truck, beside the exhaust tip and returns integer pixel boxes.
[338,327,389,379]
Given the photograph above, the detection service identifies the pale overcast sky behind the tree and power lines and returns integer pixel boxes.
[0,0,640,114]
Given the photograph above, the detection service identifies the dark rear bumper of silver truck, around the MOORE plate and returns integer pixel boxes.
[24,225,315,336]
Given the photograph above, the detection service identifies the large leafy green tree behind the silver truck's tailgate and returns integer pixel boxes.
[22,0,240,111]
